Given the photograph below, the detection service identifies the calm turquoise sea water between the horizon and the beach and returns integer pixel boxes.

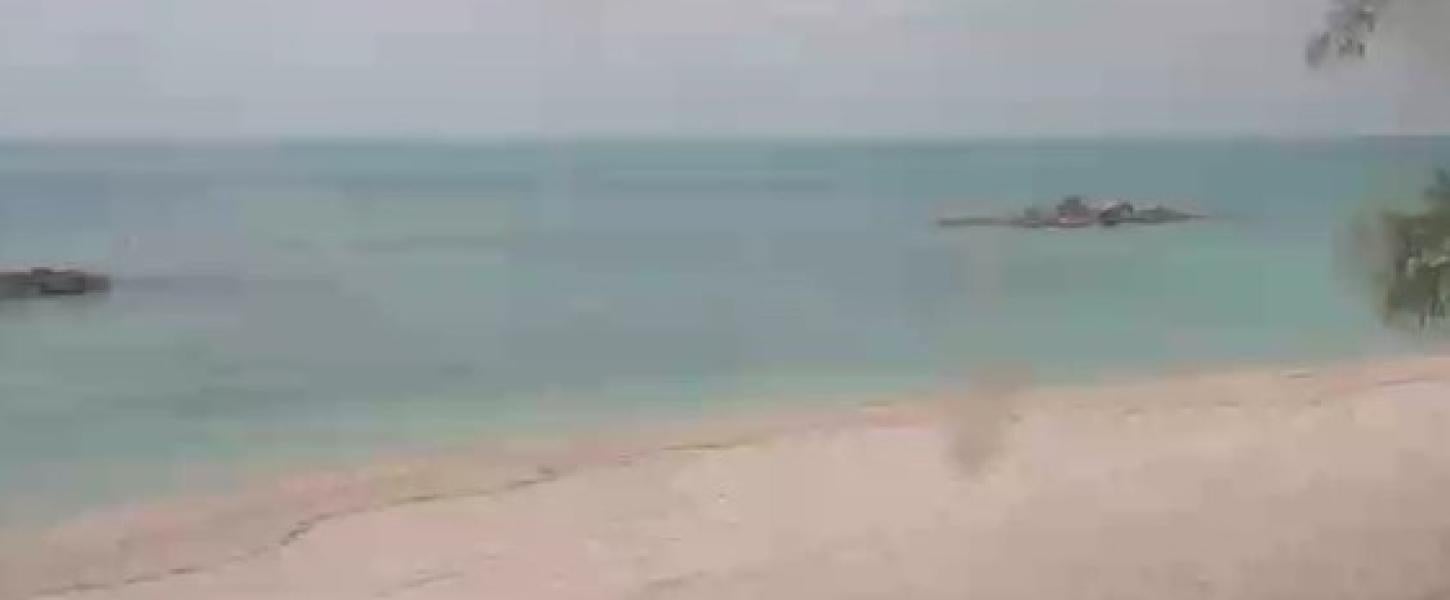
[0,138,1450,519]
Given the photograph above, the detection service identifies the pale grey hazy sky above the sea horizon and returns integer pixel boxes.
[0,0,1450,136]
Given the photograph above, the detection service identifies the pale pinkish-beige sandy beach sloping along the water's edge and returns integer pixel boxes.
[8,358,1450,600]
